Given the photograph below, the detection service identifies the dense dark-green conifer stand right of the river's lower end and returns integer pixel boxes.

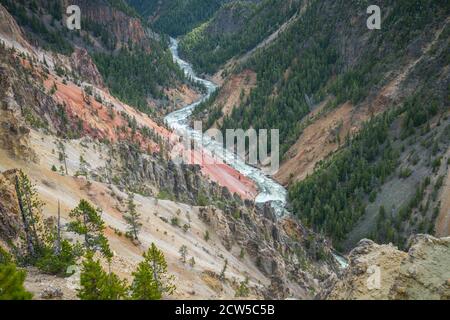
[289,115,399,245]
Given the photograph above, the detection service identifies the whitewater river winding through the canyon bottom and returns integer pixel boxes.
[165,38,287,217]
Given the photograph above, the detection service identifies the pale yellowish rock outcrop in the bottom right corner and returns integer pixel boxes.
[318,235,450,300]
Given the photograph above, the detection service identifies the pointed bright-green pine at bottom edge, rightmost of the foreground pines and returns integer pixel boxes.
[131,243,176,300]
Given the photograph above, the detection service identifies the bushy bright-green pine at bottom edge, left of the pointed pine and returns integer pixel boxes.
[77,251,128,300]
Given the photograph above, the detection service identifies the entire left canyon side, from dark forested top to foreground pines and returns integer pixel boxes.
[0,0,337,300]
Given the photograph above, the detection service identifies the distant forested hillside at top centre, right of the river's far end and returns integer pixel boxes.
[180,0,303,73]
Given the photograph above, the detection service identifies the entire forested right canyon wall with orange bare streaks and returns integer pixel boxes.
[194,1,450,250]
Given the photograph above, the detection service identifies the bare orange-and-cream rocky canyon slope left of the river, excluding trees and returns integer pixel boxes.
[0,0,336,299]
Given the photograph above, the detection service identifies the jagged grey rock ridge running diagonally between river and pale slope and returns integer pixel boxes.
[100,144,338,299]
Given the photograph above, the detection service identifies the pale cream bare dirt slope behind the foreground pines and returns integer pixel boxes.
[0,145,270,299]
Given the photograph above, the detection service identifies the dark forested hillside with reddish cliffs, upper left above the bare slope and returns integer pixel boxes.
[0,0,188,113]
